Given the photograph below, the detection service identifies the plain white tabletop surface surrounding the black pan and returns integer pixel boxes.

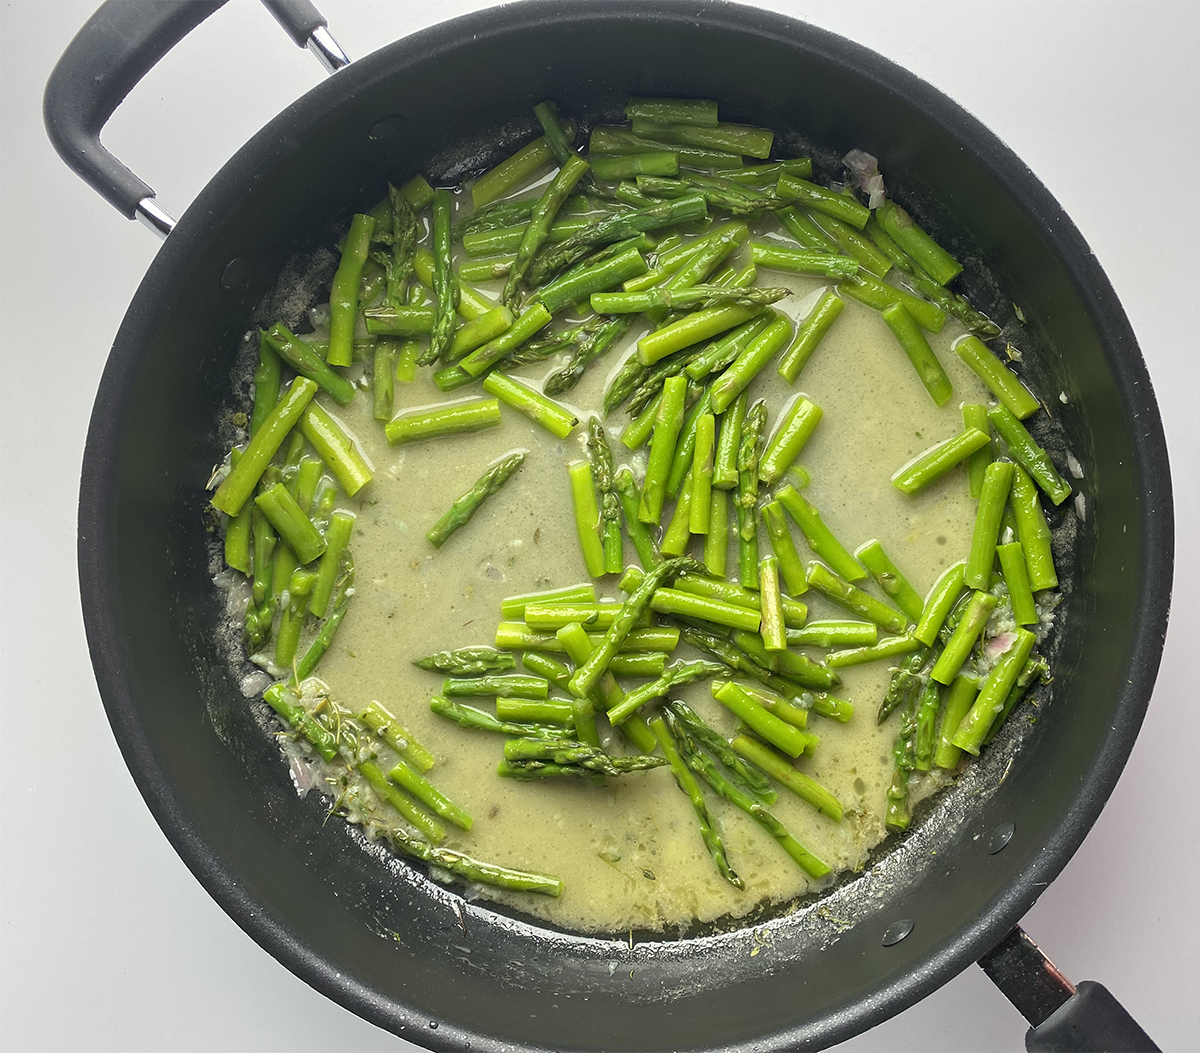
[0,0,1200,1051]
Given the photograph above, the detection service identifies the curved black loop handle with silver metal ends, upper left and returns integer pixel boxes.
[42,0,349,237]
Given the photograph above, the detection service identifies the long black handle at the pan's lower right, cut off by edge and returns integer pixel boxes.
[979,926,1158,1053]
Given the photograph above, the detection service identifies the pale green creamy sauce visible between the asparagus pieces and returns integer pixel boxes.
[295,253,986,932]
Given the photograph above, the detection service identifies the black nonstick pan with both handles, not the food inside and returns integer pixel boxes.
[44,0,1174,1051]
